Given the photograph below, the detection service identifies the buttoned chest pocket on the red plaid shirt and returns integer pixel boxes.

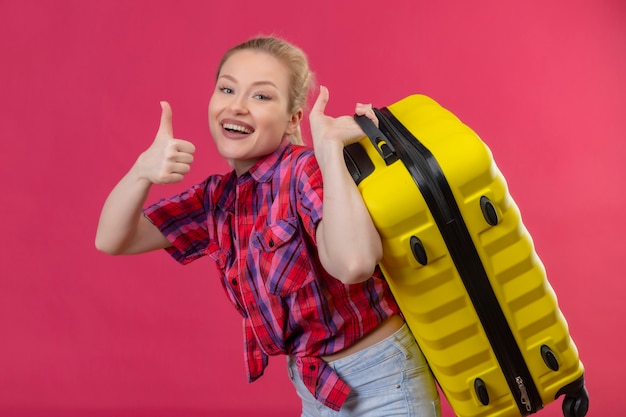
[252,217,315,297]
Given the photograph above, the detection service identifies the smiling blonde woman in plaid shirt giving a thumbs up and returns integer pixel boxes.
[96,37,440,417]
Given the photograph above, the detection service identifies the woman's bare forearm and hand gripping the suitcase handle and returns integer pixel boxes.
[309,87,382,284]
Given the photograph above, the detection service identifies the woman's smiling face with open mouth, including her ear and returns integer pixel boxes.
[209,50,302,175]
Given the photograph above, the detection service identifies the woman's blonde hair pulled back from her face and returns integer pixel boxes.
[217,36,314,144]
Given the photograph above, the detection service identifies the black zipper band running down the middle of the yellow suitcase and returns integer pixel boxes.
[374,108,543,416]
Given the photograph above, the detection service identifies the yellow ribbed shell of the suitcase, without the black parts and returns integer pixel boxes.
[347,95,588,417]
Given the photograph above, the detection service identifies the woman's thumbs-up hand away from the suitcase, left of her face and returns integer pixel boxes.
[137,101,196,184]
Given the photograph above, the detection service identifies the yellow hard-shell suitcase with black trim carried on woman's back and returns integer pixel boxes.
[344,95,589,417]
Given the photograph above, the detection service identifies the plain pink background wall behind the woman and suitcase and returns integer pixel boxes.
[0,0,626,417]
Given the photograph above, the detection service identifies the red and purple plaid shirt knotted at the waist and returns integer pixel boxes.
[144,142,399,410]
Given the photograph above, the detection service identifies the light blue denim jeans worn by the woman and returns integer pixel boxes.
[287,324,441,417]
